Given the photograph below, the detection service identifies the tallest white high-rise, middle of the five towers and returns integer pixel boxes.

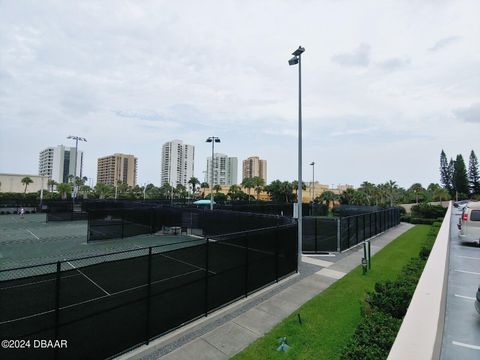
[161,140,195,187]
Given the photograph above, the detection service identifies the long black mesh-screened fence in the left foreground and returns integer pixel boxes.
[0,223,297,360]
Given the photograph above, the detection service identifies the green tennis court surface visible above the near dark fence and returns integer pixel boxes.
[0,214,204,277]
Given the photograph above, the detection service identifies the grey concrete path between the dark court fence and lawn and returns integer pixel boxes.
[119,223,413,360]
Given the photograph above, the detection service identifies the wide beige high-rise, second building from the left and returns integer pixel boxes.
[97,153,137,187]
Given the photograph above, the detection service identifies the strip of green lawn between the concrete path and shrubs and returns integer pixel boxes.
[234,225,430,360]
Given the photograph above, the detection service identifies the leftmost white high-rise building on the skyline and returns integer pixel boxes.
[38,145,83,184]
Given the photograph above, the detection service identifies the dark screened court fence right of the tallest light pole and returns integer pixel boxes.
[302,208,400,253]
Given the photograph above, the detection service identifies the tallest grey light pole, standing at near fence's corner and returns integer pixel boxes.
[288,46,305,266]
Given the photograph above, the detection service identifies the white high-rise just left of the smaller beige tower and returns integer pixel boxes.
[205,153,238,186]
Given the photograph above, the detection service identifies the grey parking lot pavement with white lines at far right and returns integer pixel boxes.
[440,212,480,360]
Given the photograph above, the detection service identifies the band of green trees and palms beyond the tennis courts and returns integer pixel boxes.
[2,173,458,206]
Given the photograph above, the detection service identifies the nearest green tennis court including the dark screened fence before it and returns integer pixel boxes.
[0,210,297,359]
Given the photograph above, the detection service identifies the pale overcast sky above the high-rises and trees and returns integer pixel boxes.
[0,0,480,187]
